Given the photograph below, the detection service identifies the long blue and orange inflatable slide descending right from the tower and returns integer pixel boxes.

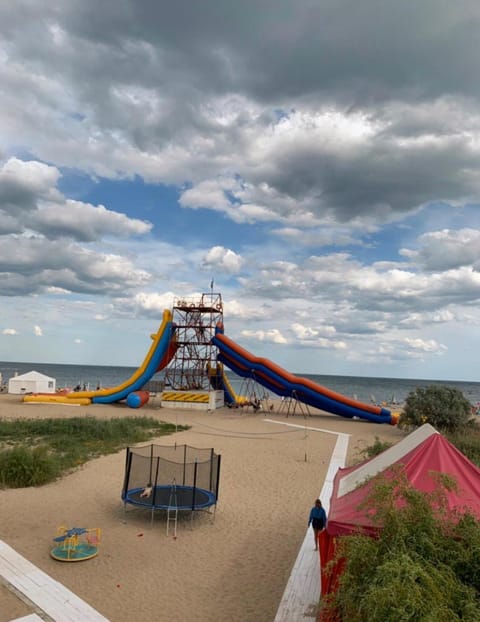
[212,325,397,425]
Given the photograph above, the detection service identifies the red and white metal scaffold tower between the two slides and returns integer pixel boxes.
[165,291,223,391]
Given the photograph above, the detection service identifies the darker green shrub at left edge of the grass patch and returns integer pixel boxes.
[0,445,60,488]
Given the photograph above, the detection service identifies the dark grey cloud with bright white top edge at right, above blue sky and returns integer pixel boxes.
[253,117,480,222]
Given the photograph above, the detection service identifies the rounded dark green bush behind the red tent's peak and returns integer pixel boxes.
[398,385,472,432]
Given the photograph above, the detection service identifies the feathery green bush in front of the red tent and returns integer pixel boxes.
[323,470,480,622]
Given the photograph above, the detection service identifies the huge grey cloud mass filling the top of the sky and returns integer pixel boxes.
[0,0,480,222]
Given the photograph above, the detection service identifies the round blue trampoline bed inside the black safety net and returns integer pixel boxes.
[123,486,217,510]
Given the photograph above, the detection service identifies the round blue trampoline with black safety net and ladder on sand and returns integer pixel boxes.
[122,444,221,532]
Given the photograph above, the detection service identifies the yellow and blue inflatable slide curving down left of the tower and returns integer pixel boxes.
[23,310,177,408]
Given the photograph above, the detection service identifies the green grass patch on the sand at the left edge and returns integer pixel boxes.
[0,417,188,488]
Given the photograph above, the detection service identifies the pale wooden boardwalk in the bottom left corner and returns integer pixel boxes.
[0,540,108,622]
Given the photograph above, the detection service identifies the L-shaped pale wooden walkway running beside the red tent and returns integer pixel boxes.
[265,419,350,622]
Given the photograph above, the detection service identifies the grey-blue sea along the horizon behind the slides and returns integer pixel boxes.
[0,361,480,405]
